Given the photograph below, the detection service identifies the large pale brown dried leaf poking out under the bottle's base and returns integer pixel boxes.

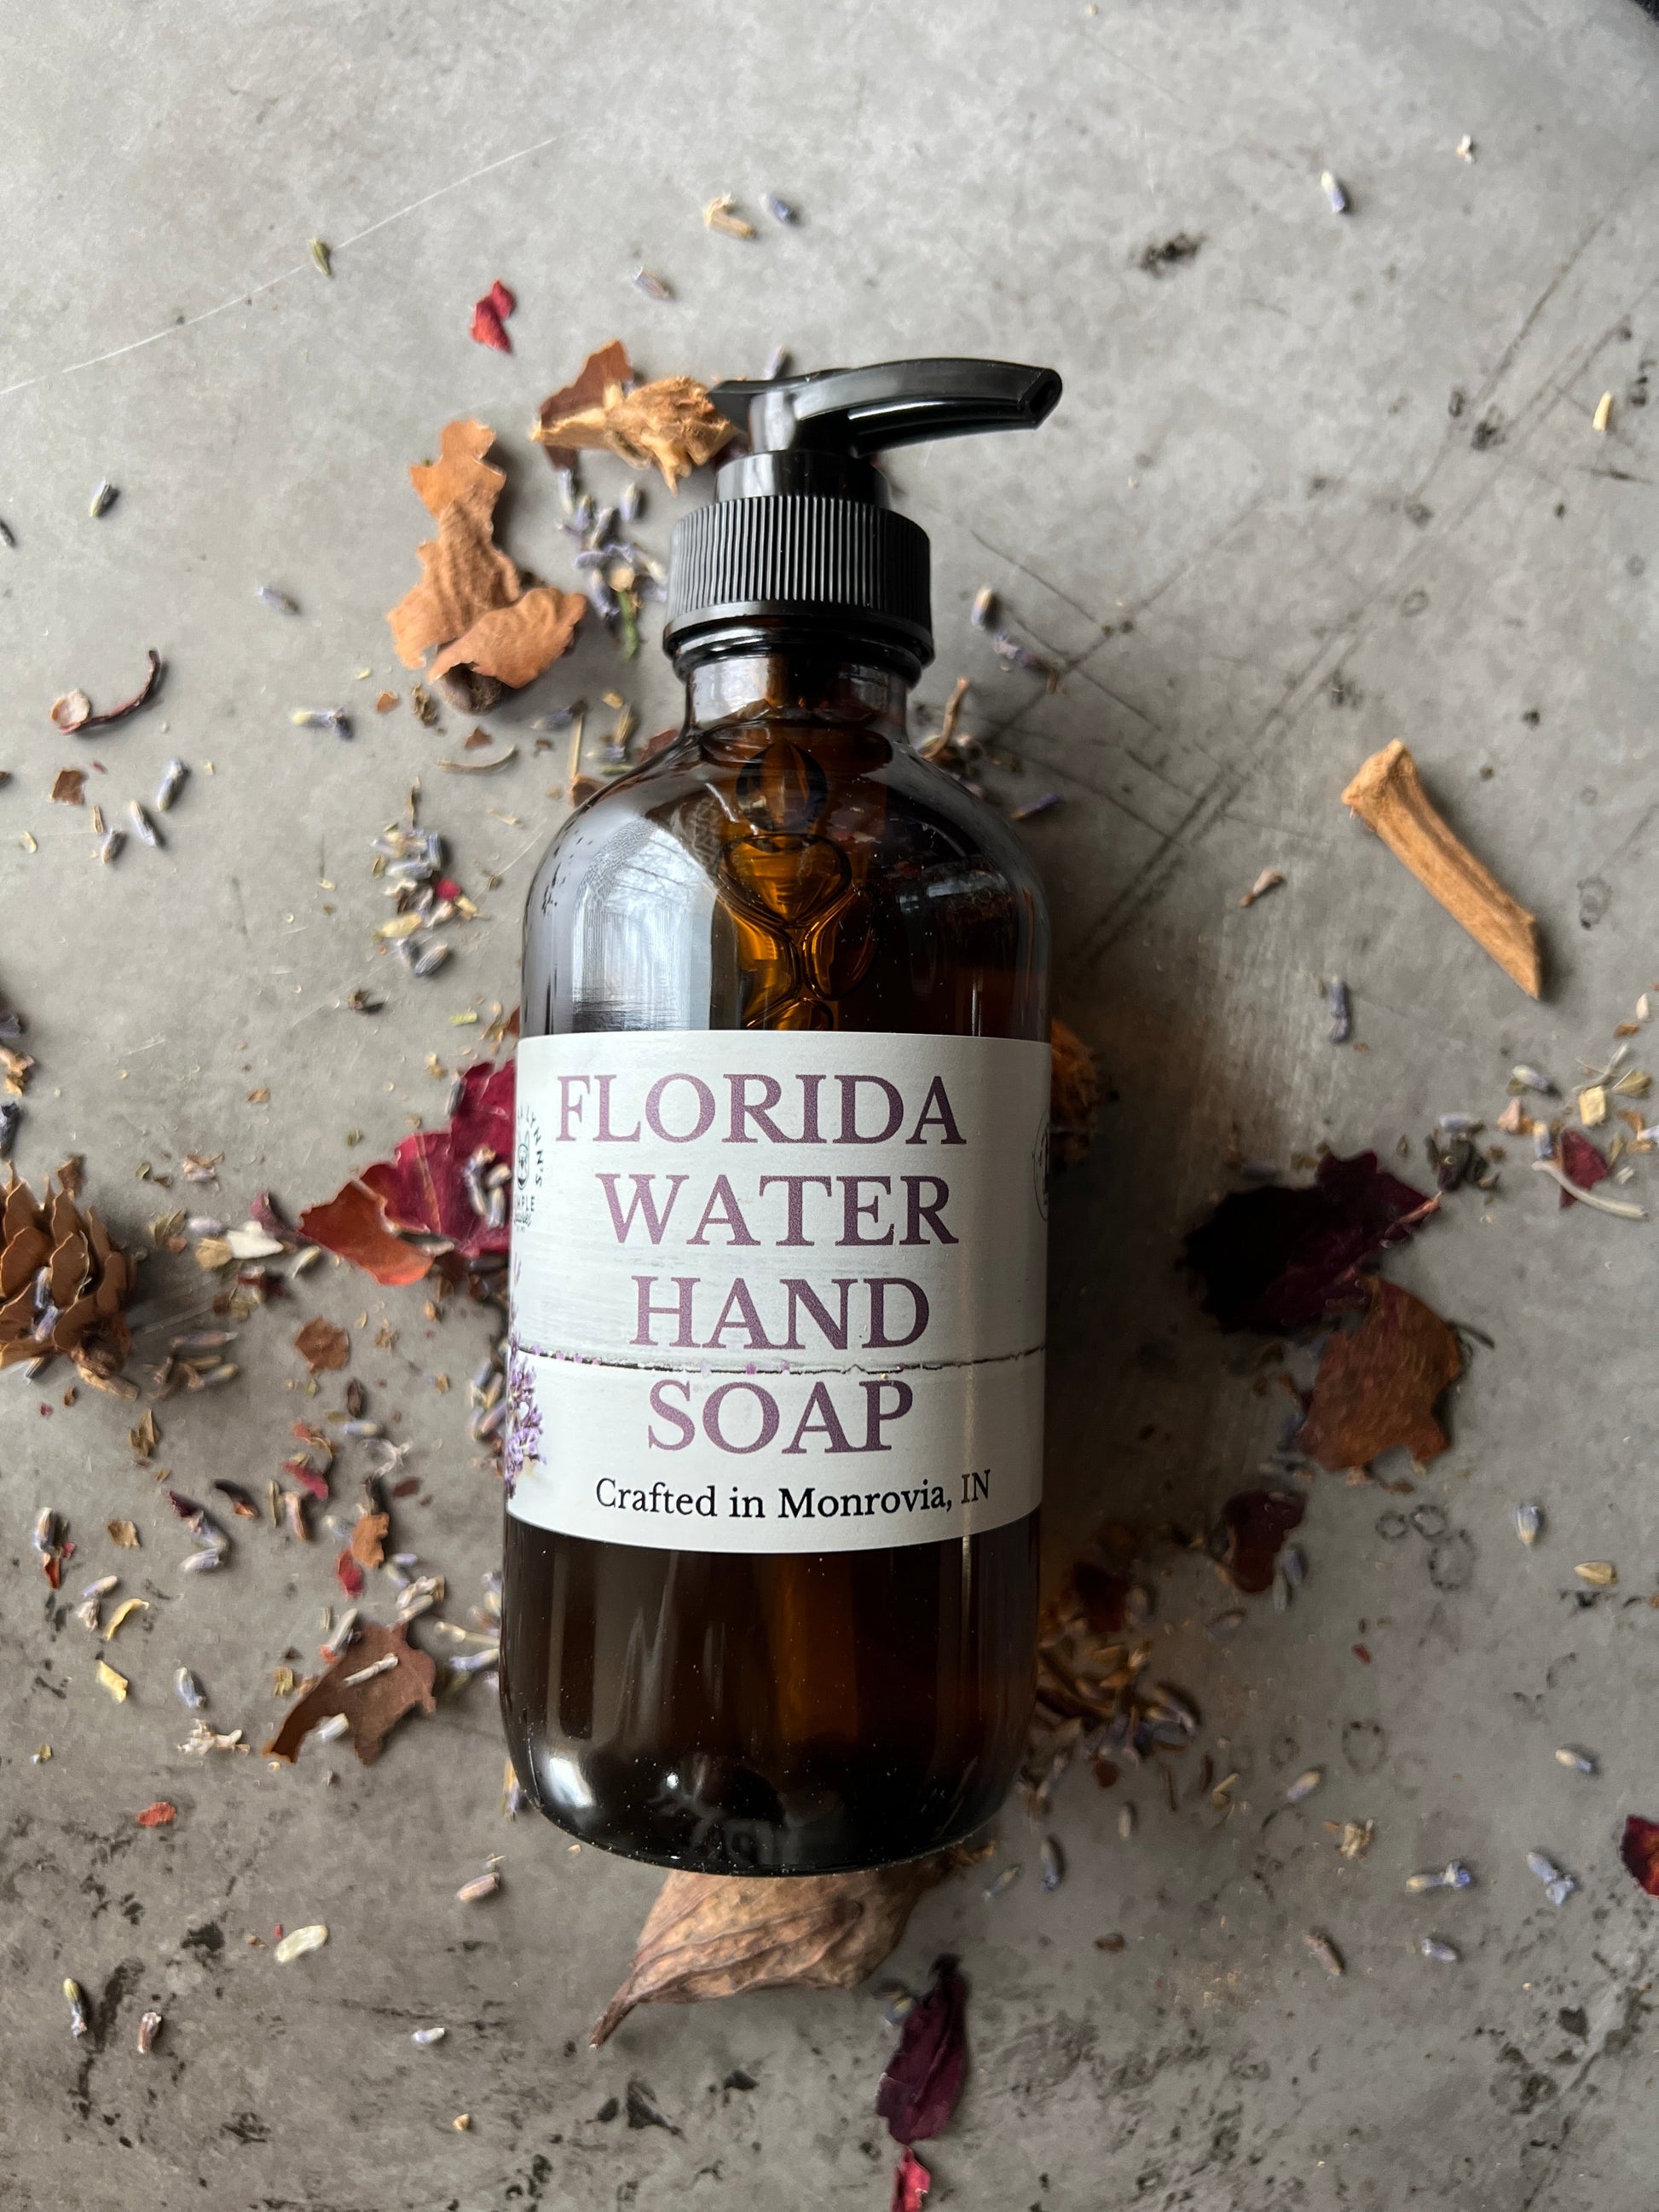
[592,1860,945,2046]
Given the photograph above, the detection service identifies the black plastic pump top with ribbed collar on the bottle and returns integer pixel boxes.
[663,361,1060,677]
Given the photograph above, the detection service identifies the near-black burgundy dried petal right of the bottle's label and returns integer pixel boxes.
[1186,1152,1440,1336]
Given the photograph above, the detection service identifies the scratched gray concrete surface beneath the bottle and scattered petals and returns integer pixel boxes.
[0,0,1659,2212]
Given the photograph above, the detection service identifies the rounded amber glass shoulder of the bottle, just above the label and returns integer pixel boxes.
[522,724,1049,1035]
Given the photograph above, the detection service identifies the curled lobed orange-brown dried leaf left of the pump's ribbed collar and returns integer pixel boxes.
[387,420,587,713]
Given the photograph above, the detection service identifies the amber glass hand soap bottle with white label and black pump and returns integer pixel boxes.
[502,363,1057,1874]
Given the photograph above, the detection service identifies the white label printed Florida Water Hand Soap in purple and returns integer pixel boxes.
[506,1031,1049,1553]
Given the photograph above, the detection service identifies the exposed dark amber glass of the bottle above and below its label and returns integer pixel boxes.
[500,653,1049,1874]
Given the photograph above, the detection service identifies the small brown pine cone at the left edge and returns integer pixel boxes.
[0,1161,137,1398]
